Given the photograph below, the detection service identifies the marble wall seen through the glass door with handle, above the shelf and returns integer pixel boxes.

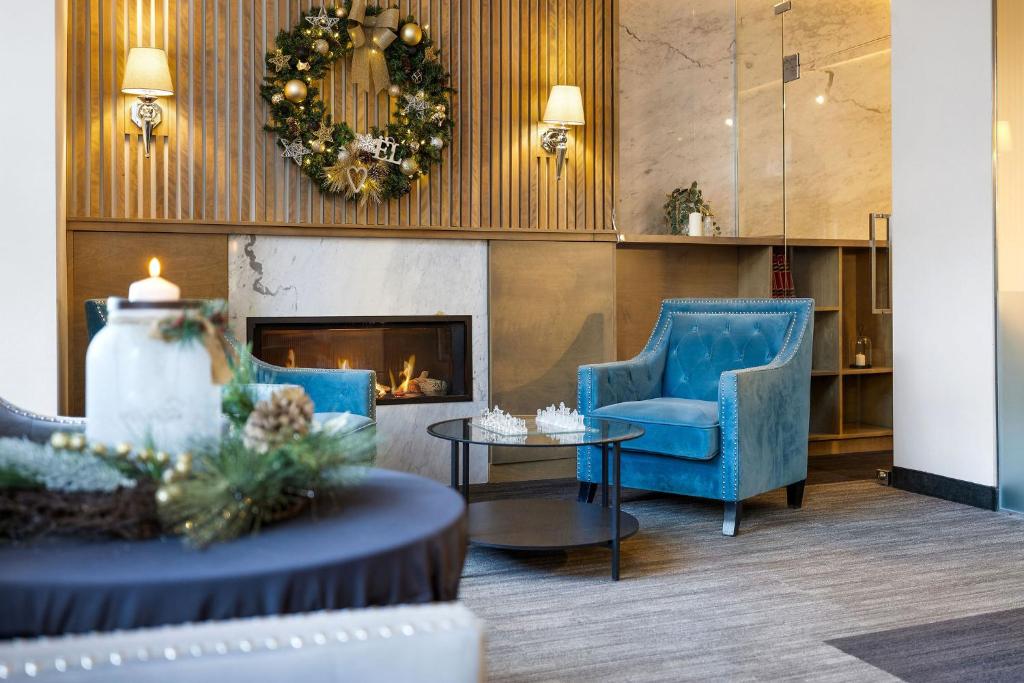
[782,0,892,240]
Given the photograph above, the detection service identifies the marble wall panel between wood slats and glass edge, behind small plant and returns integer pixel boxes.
[616,0,735,233]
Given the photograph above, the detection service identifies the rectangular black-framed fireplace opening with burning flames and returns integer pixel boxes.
[247,315,473,404]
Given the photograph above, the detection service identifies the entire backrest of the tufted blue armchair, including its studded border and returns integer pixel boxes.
[644,299,814,400]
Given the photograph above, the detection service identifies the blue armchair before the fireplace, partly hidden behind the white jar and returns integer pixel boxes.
[85,299,377,421]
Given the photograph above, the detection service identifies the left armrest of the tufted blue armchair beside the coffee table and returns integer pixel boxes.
[577,349,665,415]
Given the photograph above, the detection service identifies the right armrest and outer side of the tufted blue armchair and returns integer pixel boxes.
[719,338,811,501]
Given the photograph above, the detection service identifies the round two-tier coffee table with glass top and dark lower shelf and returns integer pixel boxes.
[427,416,644,581]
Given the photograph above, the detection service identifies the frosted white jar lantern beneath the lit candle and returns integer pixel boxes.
[85,297,220,454]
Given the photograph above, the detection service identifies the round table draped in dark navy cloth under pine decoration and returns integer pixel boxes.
[0,470,466,638]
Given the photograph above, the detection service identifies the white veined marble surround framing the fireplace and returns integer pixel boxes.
[228,234,489,483]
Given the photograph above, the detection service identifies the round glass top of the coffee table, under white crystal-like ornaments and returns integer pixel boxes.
[427,415,644,447]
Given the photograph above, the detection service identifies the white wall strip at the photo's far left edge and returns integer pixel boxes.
[0,1,62,413]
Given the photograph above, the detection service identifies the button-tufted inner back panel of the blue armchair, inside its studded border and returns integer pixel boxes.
[662,312,794,400]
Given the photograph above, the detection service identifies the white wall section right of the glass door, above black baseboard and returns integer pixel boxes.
[892,0,996,485]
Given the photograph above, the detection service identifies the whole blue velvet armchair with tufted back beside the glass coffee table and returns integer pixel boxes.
[577,299,814,536]
